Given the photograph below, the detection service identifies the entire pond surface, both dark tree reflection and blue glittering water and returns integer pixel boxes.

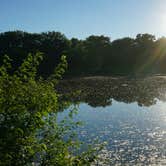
[59,77,166,165]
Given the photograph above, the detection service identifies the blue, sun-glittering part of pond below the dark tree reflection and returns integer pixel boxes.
[60,100,166,165]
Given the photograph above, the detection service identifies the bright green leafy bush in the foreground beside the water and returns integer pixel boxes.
[0,53,99,166]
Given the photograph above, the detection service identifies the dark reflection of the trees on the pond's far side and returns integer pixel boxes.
[58,77,166,107]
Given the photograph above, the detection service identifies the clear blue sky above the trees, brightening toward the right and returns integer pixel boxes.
[0,0,166,39]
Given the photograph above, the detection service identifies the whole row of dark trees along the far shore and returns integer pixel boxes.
[0,31,166,77]
